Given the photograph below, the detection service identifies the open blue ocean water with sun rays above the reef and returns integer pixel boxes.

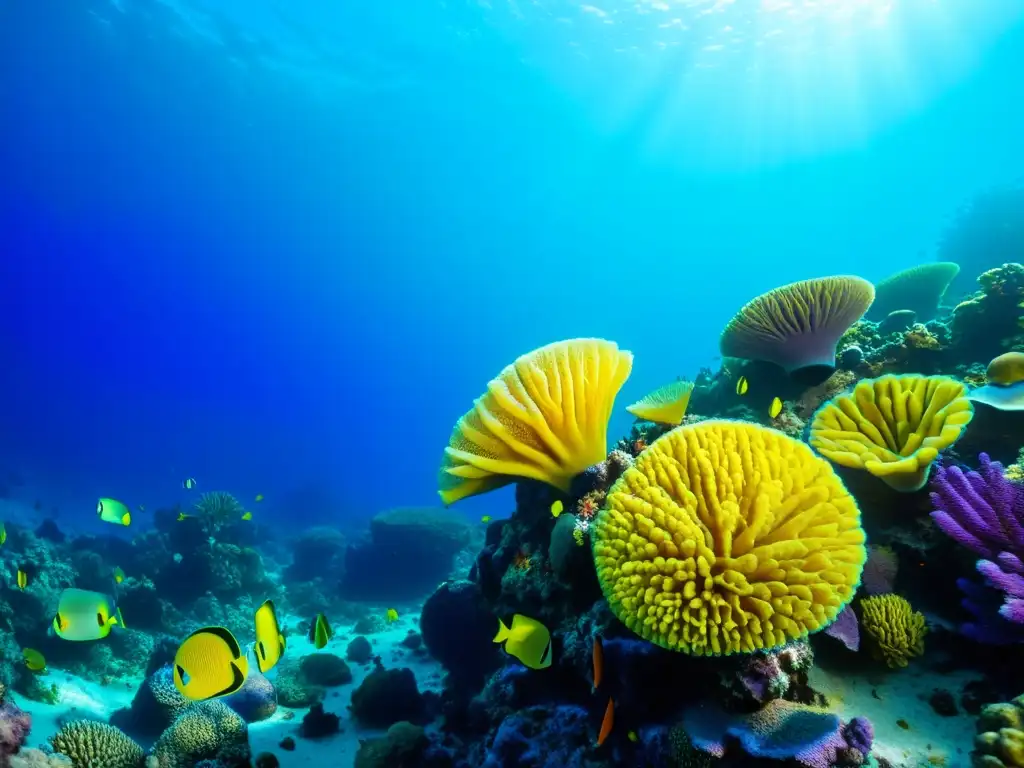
[0,0,1024,525]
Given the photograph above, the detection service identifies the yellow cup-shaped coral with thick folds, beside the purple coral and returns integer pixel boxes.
[809,375,974,490]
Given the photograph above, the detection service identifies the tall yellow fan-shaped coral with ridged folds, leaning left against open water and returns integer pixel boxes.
[438,339,633,504]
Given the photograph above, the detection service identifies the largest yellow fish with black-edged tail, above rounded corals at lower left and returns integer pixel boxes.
[174,627,249,701]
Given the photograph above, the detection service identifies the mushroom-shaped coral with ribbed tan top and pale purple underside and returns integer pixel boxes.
[719,275,874,384]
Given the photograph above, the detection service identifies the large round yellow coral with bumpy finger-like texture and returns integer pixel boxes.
[591,421,866,655]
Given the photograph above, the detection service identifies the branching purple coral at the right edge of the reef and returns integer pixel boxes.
[931,454,1024,638]
